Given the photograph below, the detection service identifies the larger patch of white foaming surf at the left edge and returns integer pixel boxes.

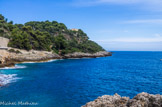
[0,74,21,86]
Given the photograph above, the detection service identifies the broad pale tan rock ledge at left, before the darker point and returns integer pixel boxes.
[0,48,61,67]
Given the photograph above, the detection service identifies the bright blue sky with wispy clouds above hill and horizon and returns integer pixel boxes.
[0,0,162,51]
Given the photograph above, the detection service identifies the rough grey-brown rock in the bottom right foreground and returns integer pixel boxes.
[82,92,162,107]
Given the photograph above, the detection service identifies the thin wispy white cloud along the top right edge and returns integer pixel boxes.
[73,0,162,11]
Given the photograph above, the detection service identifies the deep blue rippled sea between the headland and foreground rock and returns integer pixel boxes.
[0,51,162,107]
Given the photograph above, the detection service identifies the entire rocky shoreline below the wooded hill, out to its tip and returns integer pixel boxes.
[0,49,112,68]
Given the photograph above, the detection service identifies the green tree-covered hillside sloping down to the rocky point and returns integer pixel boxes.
[0,15,104,54]
